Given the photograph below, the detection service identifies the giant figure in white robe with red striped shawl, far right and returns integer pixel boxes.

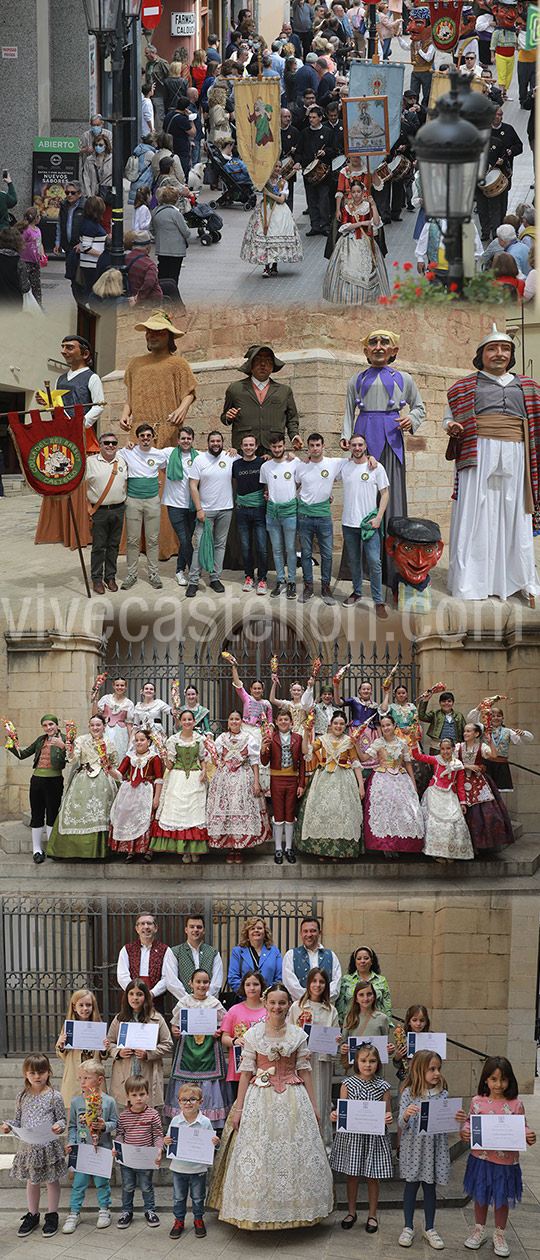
[444,324,540,607]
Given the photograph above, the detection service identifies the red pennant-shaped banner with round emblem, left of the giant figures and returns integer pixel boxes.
[8,406,86,499]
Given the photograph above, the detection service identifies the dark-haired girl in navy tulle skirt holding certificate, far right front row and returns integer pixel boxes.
[461,1055,536,1256]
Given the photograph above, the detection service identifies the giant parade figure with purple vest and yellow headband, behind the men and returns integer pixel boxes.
[340,329,425,583]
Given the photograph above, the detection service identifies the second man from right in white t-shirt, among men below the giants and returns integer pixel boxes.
[295,433,344,604]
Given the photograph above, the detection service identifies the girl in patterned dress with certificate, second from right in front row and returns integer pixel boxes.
[398,1050,464,1251]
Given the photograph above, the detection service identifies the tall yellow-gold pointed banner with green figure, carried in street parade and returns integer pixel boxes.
[234,77,281,192]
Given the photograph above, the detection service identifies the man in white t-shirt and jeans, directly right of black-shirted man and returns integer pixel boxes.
[259,433,301,600]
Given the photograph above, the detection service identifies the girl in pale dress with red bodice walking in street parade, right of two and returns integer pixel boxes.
[322,180,390,306]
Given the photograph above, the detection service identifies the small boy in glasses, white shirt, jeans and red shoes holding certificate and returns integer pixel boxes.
[165,1085,219,1239]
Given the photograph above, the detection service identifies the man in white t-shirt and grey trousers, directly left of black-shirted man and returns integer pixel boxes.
[185,428,237,599]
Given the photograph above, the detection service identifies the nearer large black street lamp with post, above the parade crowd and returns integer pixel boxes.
[412,84,485,292]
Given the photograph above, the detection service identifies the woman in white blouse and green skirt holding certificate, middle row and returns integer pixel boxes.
[164,968,233,1133]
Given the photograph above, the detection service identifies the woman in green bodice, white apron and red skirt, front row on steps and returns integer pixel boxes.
[150,709,208,862]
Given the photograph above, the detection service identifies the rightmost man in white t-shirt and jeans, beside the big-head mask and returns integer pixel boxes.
[341,433,389,620]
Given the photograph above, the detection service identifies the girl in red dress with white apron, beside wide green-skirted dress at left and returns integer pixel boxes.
[108,727,164,862]
